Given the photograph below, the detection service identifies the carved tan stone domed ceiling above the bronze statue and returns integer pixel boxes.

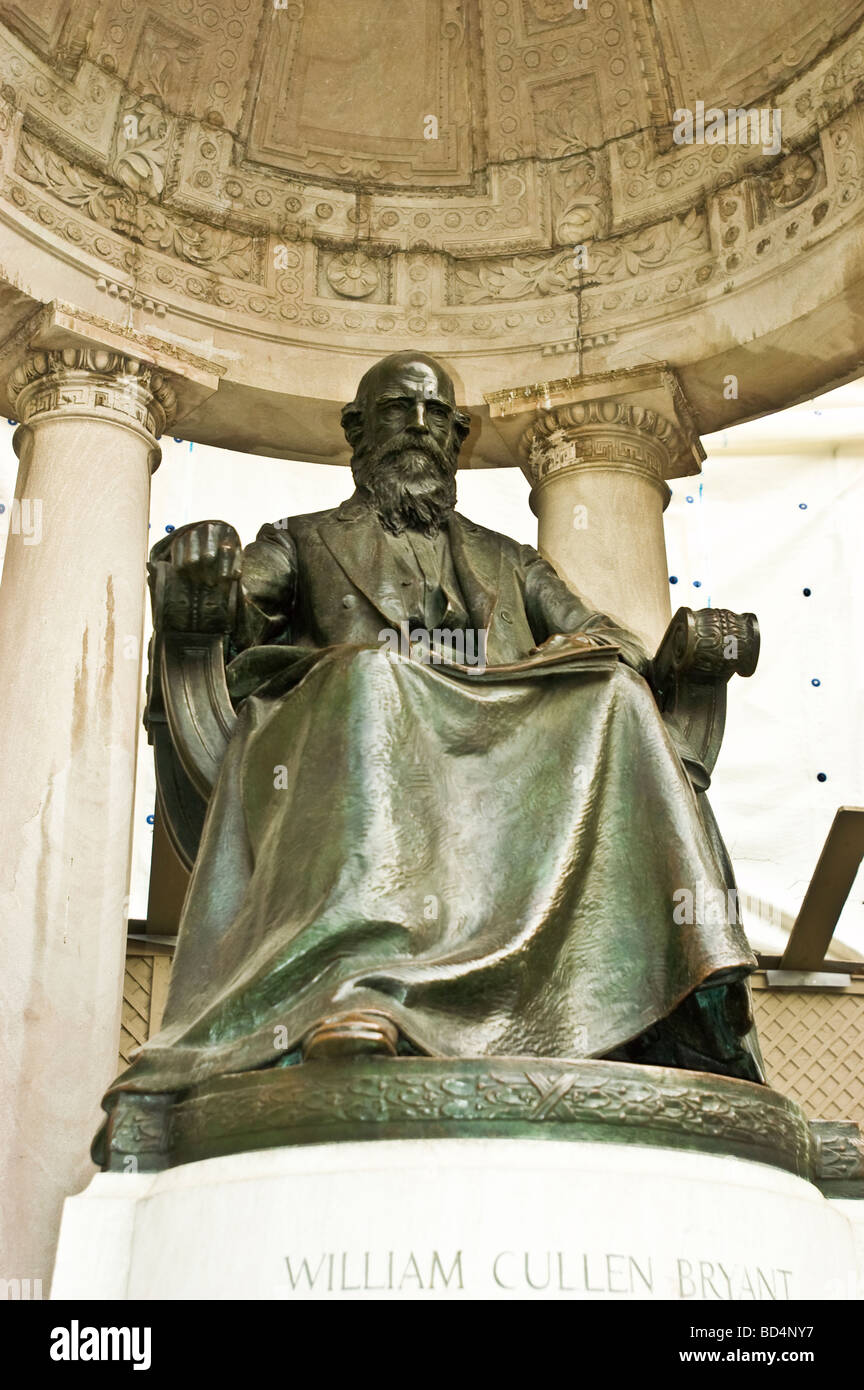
[0,0,864,463]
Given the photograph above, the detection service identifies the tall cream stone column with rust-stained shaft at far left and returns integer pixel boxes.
[0,346,175,1278]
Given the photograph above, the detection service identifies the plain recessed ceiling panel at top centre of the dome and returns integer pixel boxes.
[247,0,482,189]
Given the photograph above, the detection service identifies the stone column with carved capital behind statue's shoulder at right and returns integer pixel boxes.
[489,366,704,652]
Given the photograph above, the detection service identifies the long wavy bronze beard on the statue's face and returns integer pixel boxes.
[351,432,457,535]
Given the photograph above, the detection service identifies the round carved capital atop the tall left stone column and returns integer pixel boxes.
[8,348,176,439]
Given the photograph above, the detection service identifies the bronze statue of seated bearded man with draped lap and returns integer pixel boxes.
[110,352,763,1112]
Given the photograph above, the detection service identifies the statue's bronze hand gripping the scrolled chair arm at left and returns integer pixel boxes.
[153,521,242,632]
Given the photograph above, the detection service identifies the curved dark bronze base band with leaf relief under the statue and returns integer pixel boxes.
[96,1056,864,1197]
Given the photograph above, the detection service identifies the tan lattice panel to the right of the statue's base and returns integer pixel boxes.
[753,990,864,1126]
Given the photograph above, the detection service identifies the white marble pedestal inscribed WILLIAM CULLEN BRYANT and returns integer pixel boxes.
[51,1138,864,1316]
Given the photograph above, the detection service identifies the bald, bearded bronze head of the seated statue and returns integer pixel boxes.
[342,352,471,531]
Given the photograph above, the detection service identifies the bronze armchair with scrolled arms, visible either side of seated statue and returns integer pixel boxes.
[144,542,760,869]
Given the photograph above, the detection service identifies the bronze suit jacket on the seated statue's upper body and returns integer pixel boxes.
[230,493,649,674]
